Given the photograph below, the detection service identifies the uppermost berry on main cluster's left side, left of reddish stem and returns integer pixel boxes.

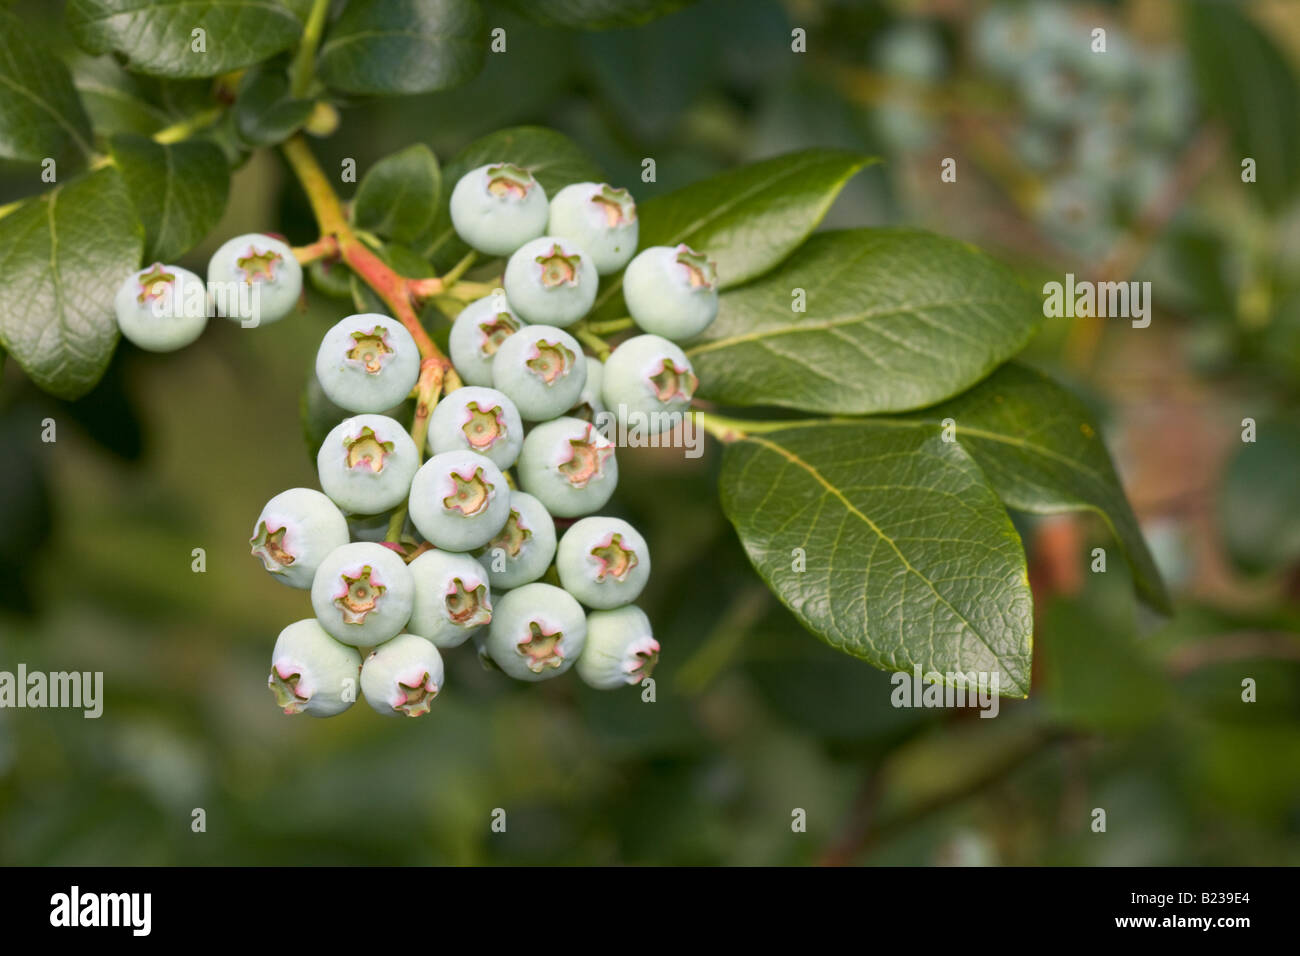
[316,312,420,412]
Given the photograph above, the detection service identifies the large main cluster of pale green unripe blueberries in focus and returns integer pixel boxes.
[251,163,718,717]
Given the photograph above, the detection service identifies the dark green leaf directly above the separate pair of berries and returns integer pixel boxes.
[111,134,230,263]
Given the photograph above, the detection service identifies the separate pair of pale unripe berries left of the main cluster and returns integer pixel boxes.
[113,233,303,352]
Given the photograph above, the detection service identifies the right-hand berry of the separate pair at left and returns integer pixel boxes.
[208,233,303,328]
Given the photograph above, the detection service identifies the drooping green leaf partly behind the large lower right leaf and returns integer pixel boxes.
[902,364,1170,611]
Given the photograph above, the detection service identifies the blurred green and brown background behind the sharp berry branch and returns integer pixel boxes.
[0,0,1300,865]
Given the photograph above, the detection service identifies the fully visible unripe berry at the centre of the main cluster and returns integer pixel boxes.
[410,451,510,551]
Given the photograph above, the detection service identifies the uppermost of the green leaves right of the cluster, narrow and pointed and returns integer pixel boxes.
[637,150,874,290]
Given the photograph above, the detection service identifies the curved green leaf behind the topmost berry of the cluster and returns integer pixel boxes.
[416,126,603,271]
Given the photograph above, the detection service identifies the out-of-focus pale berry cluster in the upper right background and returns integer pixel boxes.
[972,3,1196,258]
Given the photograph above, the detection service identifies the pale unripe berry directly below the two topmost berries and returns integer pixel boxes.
[504,235,601,326]
